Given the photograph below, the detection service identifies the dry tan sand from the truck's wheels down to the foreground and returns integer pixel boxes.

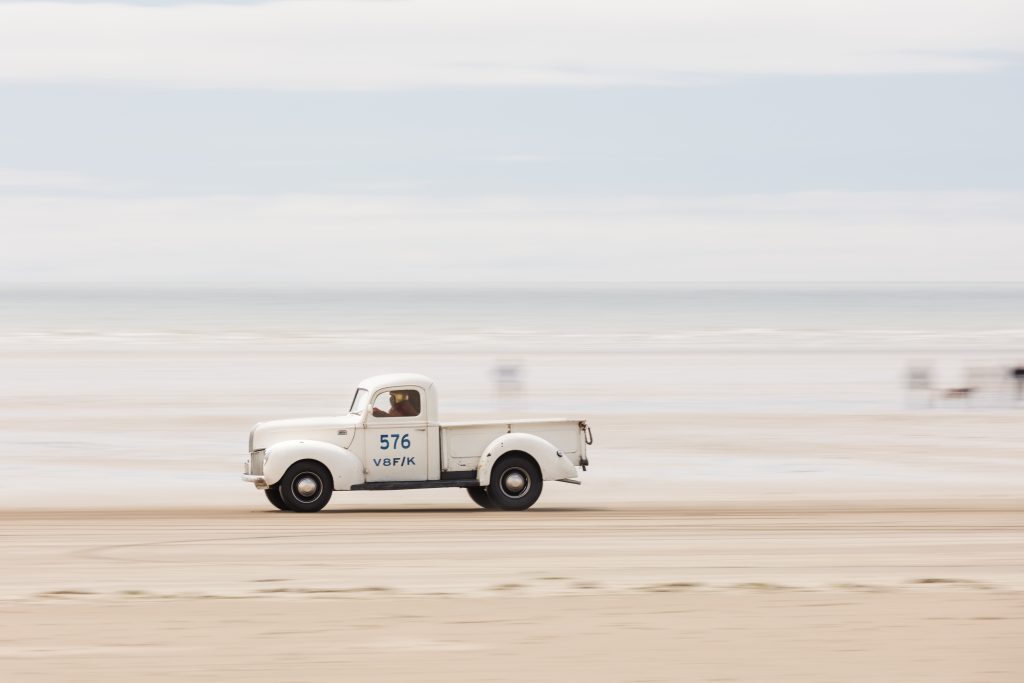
[0,501,1024,682]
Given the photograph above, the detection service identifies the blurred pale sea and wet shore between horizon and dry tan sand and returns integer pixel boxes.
[0,285,1024,509]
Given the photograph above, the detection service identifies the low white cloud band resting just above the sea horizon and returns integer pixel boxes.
[0,191,1024,286]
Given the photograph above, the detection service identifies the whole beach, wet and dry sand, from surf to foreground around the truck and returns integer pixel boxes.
[0,292,1024,683]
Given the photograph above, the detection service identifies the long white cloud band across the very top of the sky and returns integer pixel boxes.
[0,0,1024,89]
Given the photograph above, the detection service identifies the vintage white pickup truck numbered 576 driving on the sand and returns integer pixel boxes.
[242,375,593,512]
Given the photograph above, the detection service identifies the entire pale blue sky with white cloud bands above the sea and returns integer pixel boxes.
[0,0,1024,287]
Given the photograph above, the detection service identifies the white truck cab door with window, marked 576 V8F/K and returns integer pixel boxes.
[364,387,427,482]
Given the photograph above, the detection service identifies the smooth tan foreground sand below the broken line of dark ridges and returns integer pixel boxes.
[8,590,1022,683]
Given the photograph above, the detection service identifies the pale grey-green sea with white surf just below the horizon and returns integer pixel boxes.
[0,285,1024,353]
